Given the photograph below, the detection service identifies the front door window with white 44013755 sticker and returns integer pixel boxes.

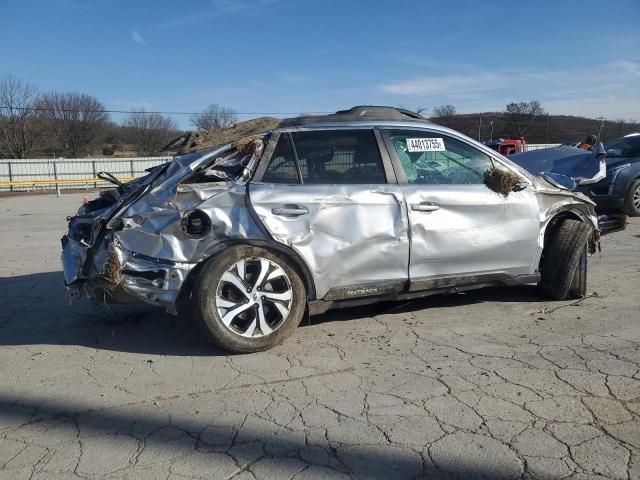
[389,130,493,185]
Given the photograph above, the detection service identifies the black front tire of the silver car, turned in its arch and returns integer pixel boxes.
[538,219,591,300]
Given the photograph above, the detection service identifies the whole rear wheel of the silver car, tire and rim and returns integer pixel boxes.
[192,245,306,353]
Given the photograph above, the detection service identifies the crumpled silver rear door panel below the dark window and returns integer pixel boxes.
[250,183,409,298]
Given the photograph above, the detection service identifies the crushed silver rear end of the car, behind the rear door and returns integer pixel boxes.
[62,138,272,314]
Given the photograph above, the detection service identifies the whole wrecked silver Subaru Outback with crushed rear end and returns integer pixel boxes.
[62,107,600,352]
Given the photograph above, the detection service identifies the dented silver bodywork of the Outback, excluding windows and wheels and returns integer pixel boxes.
[62,110,598,313]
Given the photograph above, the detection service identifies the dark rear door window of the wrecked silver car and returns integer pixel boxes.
[292,130,386,184]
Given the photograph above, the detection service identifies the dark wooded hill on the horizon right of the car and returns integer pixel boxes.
[431,112,640,143]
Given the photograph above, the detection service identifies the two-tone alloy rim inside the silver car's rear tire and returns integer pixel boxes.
[215,257,293,338]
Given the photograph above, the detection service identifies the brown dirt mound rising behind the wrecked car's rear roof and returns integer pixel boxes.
[162,117,282,154]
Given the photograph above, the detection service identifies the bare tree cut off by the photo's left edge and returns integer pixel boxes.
[0,75,42,158]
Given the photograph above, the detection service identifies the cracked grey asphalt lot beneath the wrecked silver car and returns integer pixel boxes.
[0,194,640,480]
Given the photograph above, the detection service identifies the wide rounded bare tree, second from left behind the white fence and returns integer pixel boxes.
[38,92,109,157]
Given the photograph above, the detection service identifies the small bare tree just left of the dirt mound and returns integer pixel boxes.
[124,110,176,155]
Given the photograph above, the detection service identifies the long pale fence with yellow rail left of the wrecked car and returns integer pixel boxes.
[0,157,173,192]
